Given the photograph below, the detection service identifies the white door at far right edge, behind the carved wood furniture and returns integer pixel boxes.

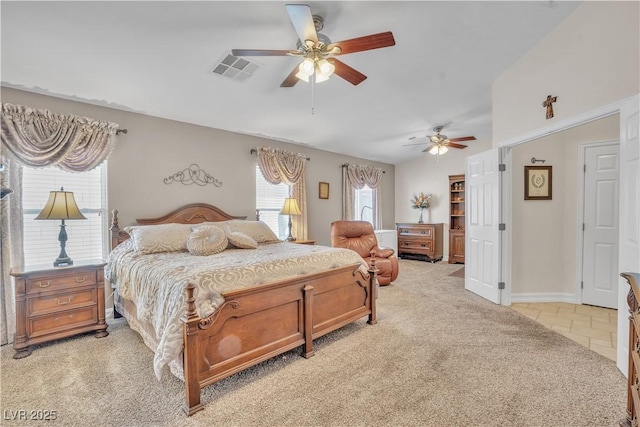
[616,95,640,375]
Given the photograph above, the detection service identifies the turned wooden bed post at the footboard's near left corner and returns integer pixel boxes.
[181,283,204,416]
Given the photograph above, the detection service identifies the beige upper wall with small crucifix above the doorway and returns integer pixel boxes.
[493,1,640,146]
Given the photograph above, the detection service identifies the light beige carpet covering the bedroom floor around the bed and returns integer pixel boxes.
[0,260,626,426]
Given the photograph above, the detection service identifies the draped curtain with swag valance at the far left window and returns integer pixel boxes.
[0,103,118,344]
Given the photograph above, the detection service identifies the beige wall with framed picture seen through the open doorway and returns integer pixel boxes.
[511,114,620,302]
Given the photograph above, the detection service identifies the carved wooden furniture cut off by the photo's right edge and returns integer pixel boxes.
[620,273,640,427]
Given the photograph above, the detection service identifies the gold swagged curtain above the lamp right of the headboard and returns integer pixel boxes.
[258,147,308,240]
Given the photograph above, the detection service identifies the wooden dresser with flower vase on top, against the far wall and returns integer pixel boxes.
[396,223,443,262]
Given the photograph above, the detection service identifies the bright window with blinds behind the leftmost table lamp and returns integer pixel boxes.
[22,163,108,265]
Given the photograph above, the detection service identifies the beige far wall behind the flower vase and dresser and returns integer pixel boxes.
[395,139,491,260]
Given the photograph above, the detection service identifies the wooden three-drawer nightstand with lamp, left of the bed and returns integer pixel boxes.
[10,261,109,359]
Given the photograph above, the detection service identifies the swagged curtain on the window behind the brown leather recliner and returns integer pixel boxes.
[342,164,383,230]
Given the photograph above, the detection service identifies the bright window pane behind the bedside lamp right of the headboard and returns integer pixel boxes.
[256,164,289,240]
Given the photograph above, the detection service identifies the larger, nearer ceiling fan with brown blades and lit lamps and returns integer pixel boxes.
[231,4,396,87]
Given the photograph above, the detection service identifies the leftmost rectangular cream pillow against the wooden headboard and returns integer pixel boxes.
[124,224,191,254]
